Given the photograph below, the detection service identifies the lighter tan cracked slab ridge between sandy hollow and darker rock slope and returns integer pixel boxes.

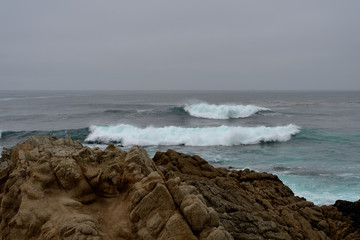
[125,146,217,240]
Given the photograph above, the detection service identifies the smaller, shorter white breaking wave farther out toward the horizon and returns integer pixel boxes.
[184,103,270,119]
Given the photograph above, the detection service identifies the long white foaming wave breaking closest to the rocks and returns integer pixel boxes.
[85,124,300,146]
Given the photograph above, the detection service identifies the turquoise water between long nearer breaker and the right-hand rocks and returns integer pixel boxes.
[136,129,360,205]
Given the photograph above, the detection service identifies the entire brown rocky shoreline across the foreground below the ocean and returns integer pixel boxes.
[0,137,360,240]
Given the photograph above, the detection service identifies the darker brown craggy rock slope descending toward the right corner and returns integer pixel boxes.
[154,150,360,240]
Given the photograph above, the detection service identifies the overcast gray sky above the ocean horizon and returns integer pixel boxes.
[0,0,360,90]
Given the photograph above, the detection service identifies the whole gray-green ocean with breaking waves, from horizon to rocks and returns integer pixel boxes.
[0,91,360,205]
